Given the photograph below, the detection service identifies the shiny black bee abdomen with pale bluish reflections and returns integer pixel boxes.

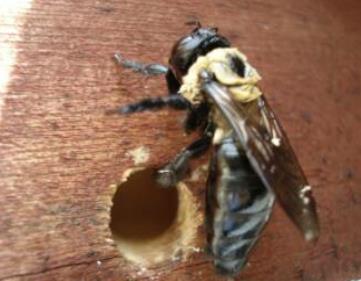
[206,138,274,275]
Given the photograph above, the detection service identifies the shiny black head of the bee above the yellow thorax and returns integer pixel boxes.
[169,27,230,82]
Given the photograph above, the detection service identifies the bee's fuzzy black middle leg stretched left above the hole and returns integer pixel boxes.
[107,95,189,114]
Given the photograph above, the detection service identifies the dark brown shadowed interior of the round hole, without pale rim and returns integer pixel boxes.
[110,169,178,240]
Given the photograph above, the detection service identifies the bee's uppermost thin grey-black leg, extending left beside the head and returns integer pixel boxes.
[114,53,168,76]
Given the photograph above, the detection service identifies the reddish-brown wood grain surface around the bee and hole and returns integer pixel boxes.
[0,0,361,281]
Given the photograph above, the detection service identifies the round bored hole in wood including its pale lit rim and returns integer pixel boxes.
[110,169,201,266]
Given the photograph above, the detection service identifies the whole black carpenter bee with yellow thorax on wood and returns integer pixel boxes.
[111,24,319,275]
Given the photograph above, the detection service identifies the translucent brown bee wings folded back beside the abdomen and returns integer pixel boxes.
[202,77,319,240]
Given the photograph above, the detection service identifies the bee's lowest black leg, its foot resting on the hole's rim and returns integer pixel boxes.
[157,126,213,187]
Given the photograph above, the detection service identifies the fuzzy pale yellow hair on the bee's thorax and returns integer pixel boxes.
[179,48,262,104]
